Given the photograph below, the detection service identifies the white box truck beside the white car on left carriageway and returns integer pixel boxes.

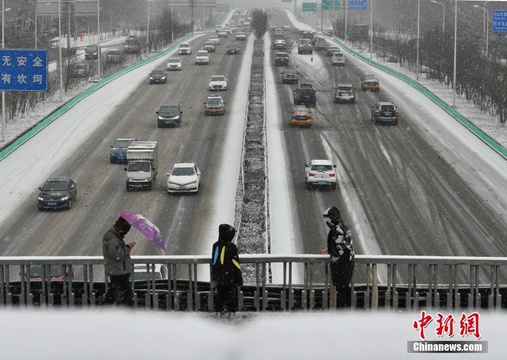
[125,141,158,191]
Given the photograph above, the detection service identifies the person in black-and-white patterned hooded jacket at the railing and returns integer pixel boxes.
[323,206,355,307]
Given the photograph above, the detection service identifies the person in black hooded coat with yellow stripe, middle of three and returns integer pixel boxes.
[211,224,243,318]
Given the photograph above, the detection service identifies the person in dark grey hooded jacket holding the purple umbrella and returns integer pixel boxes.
[102,216,135,306]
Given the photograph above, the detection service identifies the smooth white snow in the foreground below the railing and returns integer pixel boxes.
[0,309,505,360]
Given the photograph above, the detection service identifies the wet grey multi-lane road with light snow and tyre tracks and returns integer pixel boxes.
[0,12,507,284]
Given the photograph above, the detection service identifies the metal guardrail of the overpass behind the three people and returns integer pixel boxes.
[0,254,507,311]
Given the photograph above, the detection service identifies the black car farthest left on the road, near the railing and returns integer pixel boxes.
[37,177,77,210]
